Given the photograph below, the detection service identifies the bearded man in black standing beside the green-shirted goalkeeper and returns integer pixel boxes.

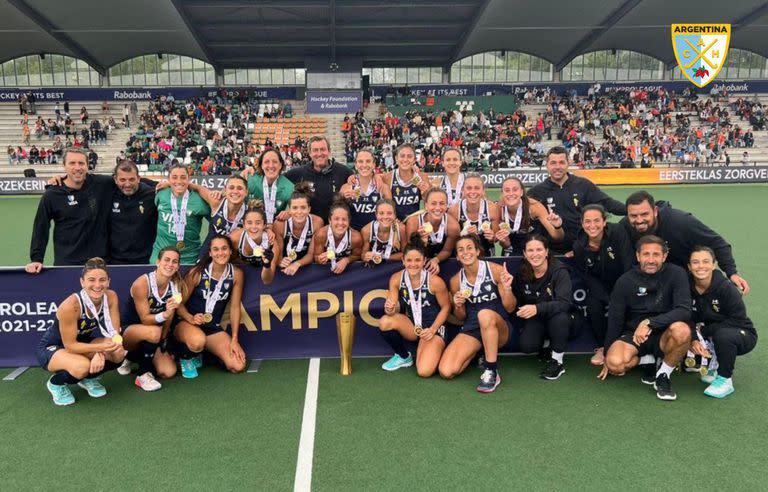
[109,160,157,265]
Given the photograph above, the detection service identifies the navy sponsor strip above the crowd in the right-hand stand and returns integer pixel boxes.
[371,80,768,97]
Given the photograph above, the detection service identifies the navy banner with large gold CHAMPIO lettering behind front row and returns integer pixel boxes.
[0,258,595,367]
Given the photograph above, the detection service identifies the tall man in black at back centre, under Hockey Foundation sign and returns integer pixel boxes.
[285,137,353,223]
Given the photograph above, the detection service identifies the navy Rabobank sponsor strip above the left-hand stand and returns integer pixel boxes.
[0,87,299,102]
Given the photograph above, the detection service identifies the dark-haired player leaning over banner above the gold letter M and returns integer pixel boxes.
[274,181,323,275]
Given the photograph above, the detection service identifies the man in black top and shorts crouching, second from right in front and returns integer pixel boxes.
[600,235,691,400]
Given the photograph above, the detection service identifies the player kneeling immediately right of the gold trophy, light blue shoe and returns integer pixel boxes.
[379,233,451,378]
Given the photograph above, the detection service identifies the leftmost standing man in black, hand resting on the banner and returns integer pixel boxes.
[26,149,114,273]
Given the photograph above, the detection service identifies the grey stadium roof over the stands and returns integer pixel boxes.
[0,0,768,72]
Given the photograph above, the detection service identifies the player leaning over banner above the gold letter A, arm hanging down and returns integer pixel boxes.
[231,200,283,285]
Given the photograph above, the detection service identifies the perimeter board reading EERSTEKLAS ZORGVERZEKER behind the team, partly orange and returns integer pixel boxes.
[0,166,768,195]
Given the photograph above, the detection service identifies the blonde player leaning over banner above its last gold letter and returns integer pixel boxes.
[360,198,406,265]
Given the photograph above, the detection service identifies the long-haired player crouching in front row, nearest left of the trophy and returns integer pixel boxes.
[174,236,246,379]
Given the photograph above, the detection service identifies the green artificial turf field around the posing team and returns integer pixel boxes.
[0,185,768,491]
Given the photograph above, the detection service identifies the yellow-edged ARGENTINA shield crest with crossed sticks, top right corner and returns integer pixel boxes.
[672,24,731,87]
